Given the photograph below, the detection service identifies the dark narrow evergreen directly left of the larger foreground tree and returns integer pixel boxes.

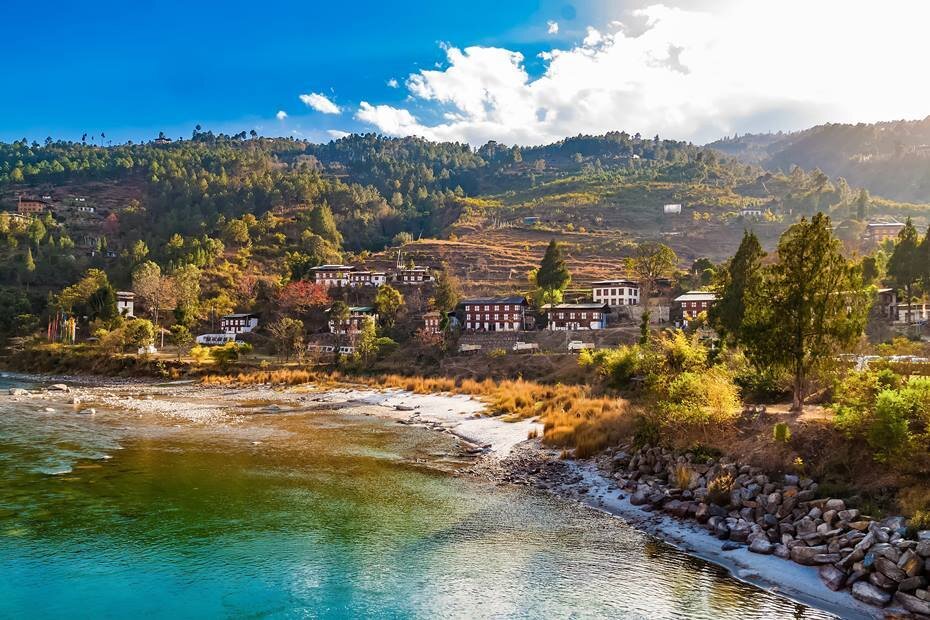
[708,231,765,343]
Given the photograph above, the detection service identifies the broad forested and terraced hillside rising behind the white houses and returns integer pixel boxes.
[0,127,926,331]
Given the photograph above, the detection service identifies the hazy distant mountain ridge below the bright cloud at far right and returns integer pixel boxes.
[706,116,930,202]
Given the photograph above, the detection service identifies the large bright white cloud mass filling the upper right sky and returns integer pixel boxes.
[356,0,930,144]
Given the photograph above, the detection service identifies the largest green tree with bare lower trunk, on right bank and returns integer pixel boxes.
[744,213,871,411]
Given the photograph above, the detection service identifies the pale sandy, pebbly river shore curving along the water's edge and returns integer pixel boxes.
[3,378,883,618]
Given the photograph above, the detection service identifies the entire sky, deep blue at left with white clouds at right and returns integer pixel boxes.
[0,0,930,144]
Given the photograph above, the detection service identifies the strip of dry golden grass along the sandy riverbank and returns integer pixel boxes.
[203,370,633,458]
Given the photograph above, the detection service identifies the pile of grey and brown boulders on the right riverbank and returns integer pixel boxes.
[598,447,930,617]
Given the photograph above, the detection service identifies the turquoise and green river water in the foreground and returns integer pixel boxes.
[0,378,828,620]
